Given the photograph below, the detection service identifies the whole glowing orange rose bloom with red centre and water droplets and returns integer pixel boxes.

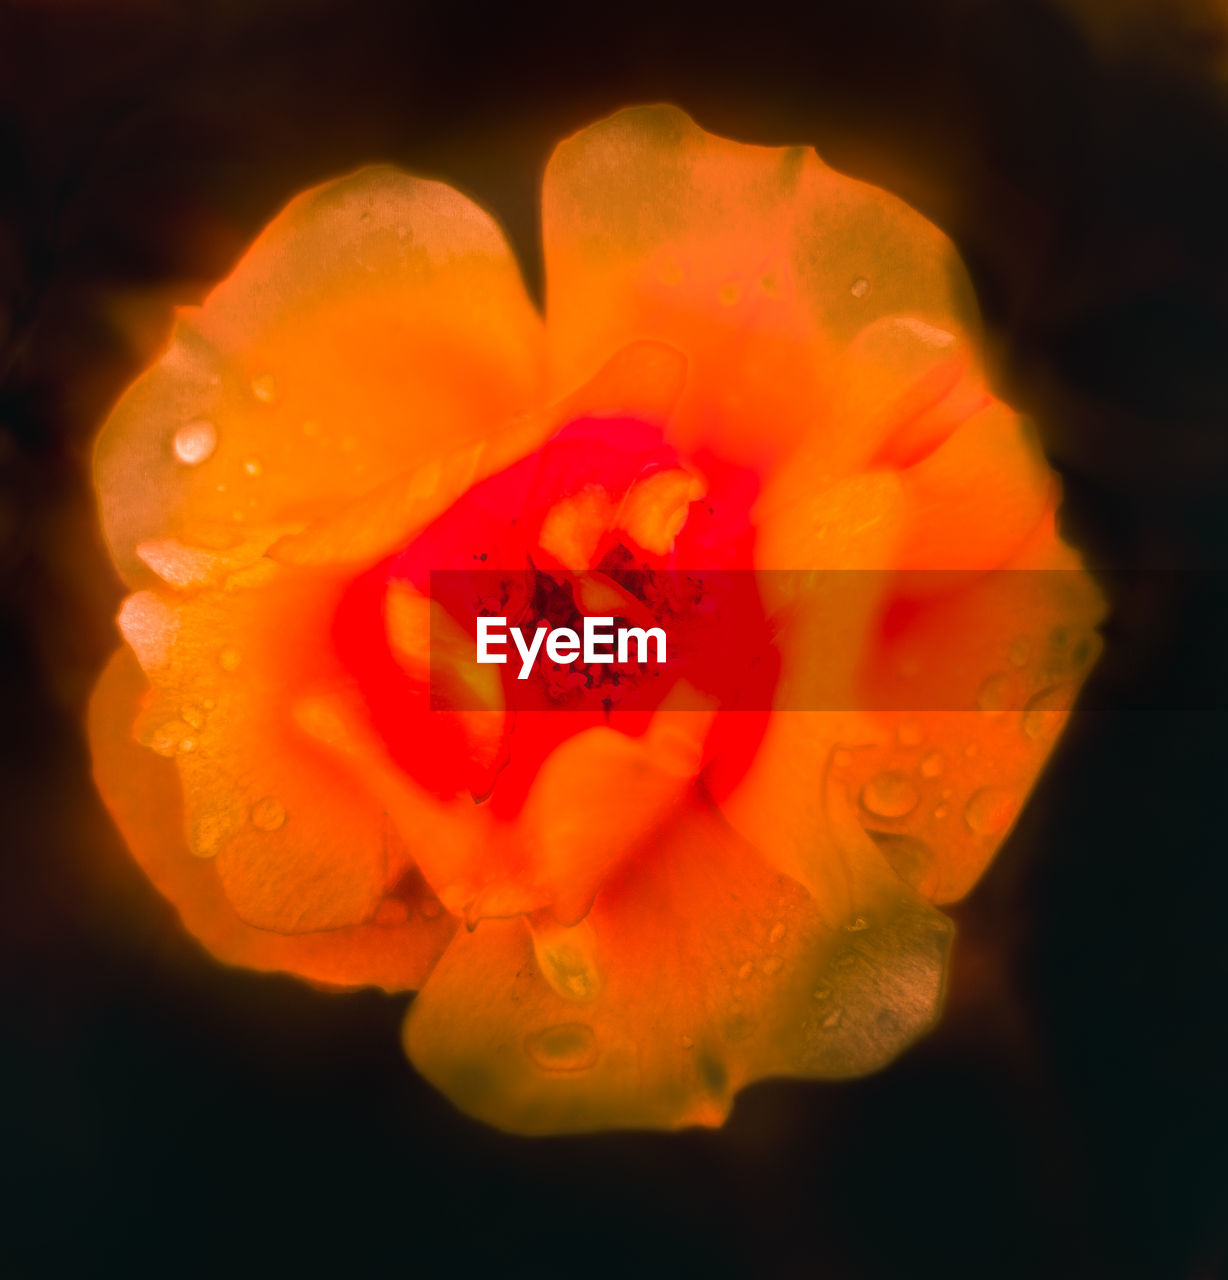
[91,108,1100,1133]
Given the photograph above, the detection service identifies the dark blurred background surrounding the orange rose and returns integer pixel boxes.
[0,0,1228,1280]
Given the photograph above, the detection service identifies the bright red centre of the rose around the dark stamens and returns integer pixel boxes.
[334,417,776,817]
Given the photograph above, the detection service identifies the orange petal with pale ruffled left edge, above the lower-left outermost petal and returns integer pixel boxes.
[110,566,406,933]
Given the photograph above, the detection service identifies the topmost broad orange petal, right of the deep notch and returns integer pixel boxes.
[542,106,971,462]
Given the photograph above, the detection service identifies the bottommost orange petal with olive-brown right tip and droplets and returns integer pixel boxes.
[406,803,950,1133]
